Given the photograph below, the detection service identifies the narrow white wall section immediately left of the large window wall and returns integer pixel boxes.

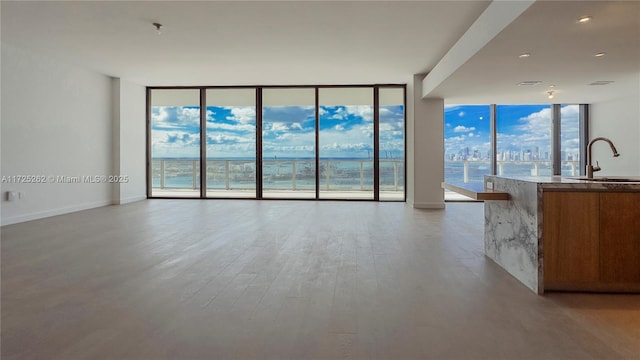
[112,79,146,204]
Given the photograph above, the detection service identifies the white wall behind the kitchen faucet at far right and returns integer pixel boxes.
[589,75,640,176]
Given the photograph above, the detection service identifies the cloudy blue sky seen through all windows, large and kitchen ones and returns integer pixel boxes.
[151,101,579,159]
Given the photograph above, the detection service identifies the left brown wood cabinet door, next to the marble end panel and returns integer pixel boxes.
[542,192,600,290]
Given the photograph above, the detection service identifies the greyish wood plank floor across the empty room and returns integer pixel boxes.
[1,200,640,359]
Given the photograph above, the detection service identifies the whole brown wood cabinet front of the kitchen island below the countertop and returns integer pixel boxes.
[542,192,640,291]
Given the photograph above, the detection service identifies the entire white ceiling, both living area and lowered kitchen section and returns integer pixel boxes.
[1,0,640,103]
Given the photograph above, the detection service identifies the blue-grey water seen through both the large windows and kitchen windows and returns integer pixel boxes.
[152,159,578,191]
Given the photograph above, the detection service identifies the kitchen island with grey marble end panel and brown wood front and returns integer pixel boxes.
[484,176,640,294]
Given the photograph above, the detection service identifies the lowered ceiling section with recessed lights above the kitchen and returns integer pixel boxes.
[429,1,640,103]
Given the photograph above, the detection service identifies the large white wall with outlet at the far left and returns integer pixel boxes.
[1,43,112,225]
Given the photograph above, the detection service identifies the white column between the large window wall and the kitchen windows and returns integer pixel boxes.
[407,75,444,209]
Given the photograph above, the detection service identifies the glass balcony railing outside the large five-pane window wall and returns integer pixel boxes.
[151,158,404,192]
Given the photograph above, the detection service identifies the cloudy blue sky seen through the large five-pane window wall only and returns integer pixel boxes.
[151,105,404,159]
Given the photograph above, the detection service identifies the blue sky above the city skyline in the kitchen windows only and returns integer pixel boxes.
[444,105,580,157]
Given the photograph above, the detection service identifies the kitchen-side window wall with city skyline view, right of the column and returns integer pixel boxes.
[444,104,588,199]
